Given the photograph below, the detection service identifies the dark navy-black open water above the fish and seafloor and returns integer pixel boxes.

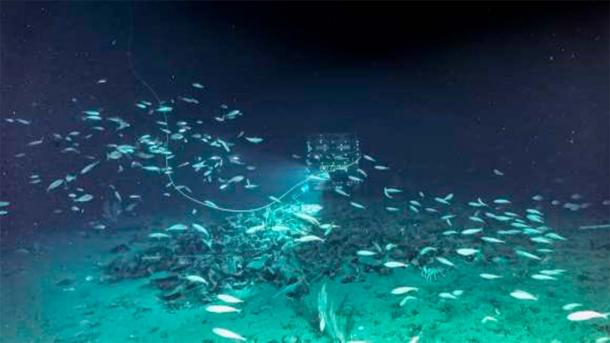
[0,2,610,239]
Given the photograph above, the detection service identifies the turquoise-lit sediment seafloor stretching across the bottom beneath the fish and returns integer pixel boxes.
[1,200,610,343]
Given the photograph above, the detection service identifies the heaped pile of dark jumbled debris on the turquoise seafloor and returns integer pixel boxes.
[104,199,460,307]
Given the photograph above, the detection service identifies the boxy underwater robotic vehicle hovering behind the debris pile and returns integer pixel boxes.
[306,133,361,190]
